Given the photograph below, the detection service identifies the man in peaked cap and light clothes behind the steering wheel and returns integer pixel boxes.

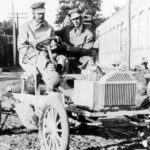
[18,2,59,90]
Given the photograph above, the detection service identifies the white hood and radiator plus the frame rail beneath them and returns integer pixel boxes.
[67,70,149,119]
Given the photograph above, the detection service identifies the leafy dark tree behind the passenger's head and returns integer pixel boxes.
[55,0,105,27]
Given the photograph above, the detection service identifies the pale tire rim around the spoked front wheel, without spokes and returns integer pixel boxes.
[39,99,69,150]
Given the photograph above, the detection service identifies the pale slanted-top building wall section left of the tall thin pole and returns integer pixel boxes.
[99,4,127,67]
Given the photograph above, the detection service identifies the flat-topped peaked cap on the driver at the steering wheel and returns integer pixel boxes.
[31,2,45,13]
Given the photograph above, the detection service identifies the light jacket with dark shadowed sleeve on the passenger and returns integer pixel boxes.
[56,25,94,64]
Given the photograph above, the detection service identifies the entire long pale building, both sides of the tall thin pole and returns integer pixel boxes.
[98,0,150,68]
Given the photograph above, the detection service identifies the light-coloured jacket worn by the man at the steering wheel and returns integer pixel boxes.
[18,19,54,61]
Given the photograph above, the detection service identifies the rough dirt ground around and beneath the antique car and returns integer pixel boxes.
[0,72,148,150]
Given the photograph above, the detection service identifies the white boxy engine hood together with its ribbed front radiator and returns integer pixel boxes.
[73,71,137,110]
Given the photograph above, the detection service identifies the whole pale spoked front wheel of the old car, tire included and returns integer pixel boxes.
[39,99,69,150]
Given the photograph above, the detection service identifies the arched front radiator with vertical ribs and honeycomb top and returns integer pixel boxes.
[97,71,137,107]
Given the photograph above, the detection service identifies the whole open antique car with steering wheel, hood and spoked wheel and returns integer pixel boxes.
[2,38,150,150]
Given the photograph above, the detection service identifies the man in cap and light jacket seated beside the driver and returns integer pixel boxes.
[56,8,94,73]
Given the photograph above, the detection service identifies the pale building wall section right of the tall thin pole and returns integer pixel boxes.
[131,0,150,68]
